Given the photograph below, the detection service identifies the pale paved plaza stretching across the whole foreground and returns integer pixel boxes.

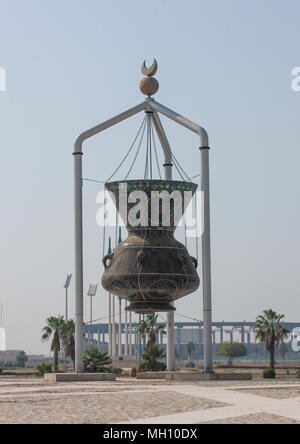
[0,378,300,424]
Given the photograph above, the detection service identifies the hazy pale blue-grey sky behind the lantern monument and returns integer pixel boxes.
[0,0,300,353]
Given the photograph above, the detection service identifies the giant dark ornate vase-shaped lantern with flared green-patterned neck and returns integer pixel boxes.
[102,180,199,313]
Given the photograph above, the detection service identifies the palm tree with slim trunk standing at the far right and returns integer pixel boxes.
[254,309,289,370]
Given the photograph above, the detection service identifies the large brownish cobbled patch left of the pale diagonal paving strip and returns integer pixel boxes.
[0,391,226,424]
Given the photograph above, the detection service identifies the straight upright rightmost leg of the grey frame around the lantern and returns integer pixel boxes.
[200,147,213,373]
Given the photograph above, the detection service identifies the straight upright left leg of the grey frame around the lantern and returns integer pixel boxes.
[74,151,83,373]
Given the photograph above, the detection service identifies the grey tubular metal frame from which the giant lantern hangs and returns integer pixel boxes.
[73,98,212,373]
